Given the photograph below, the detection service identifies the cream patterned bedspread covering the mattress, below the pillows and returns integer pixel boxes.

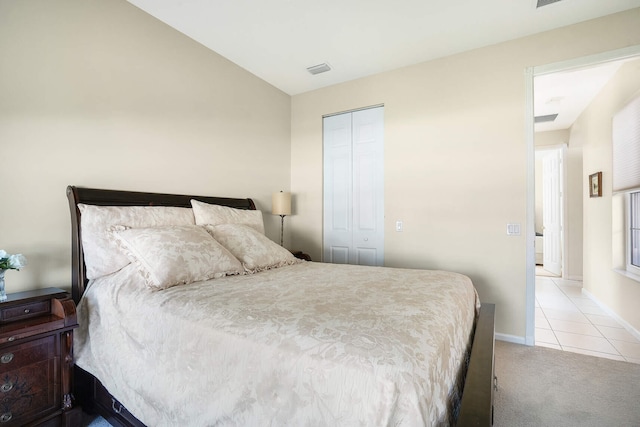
[75,262,479,427]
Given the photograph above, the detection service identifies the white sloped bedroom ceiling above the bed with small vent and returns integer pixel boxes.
[128,0,640,95]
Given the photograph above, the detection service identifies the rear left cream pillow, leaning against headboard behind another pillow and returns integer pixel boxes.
[78,204,195,279]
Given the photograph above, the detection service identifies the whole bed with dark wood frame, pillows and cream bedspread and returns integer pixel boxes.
[67,186,495,426]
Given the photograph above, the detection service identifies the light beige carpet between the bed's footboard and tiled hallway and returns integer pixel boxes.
[494,341,640,427]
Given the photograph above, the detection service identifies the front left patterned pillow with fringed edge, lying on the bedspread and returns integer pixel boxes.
[111,225,242,289]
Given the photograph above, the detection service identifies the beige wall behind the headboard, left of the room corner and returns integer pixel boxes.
[0,0,290,292]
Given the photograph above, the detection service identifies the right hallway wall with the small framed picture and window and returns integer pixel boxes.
[571,60,640,331]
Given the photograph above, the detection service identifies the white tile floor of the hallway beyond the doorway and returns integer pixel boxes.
[535,268,640,364]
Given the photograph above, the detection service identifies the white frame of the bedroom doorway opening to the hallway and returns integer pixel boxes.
[524,45,640,346]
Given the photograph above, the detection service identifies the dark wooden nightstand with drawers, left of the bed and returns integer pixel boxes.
[0,288,82,427]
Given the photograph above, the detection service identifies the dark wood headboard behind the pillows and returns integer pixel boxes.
[67,185,256,304]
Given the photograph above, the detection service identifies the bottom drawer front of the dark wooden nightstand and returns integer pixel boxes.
[0,358,60,426]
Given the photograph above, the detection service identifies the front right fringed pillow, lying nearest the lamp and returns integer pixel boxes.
[204,224,301,273]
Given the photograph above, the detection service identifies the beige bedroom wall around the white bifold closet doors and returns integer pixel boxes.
[291,9,640,339]
